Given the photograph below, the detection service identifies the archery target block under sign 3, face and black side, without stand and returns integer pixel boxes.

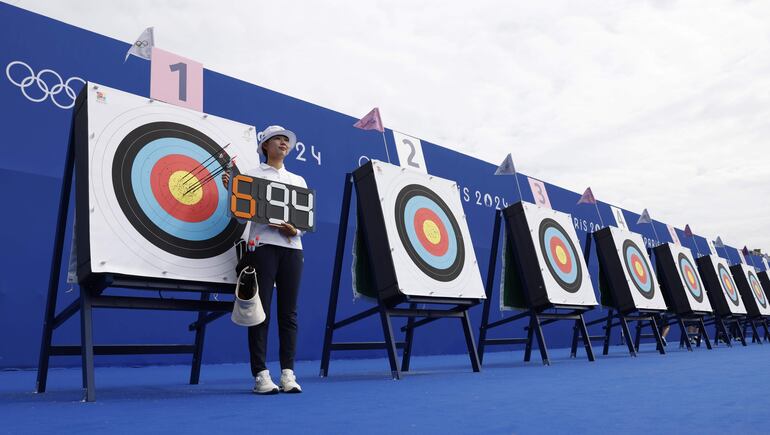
[503,202,597,308]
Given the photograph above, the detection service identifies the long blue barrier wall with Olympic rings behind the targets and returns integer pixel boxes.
[0,3,760,369]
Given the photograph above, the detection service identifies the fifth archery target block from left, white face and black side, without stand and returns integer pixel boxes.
[653,243,713,314]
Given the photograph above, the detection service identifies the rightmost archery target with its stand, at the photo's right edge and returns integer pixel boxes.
[730,264,770,344]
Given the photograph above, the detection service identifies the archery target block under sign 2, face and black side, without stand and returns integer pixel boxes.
[353,160,486,299]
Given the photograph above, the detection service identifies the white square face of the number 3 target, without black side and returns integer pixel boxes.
[523,203,597,306]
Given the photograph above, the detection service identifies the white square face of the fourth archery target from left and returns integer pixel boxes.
[610,227,667,311]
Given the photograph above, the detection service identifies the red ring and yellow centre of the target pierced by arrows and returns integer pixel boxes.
[150,154,219,222]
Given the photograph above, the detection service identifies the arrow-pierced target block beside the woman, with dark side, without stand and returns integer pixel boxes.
[75,83,259,284]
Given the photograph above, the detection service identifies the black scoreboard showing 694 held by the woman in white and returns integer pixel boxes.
[230,174,315,231]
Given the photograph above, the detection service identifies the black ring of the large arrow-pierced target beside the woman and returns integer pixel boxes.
[112,122,245,259]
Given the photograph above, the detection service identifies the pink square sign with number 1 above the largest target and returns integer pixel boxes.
[150,47,203,112]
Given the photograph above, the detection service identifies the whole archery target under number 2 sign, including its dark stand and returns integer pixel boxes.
[320,160,484,379]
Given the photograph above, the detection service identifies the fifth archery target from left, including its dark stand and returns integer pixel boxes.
[649,243,713,352]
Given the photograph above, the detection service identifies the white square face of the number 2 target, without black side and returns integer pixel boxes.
[373,161,485,298]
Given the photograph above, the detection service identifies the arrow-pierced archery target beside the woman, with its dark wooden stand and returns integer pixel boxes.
[35,83,254,402]
